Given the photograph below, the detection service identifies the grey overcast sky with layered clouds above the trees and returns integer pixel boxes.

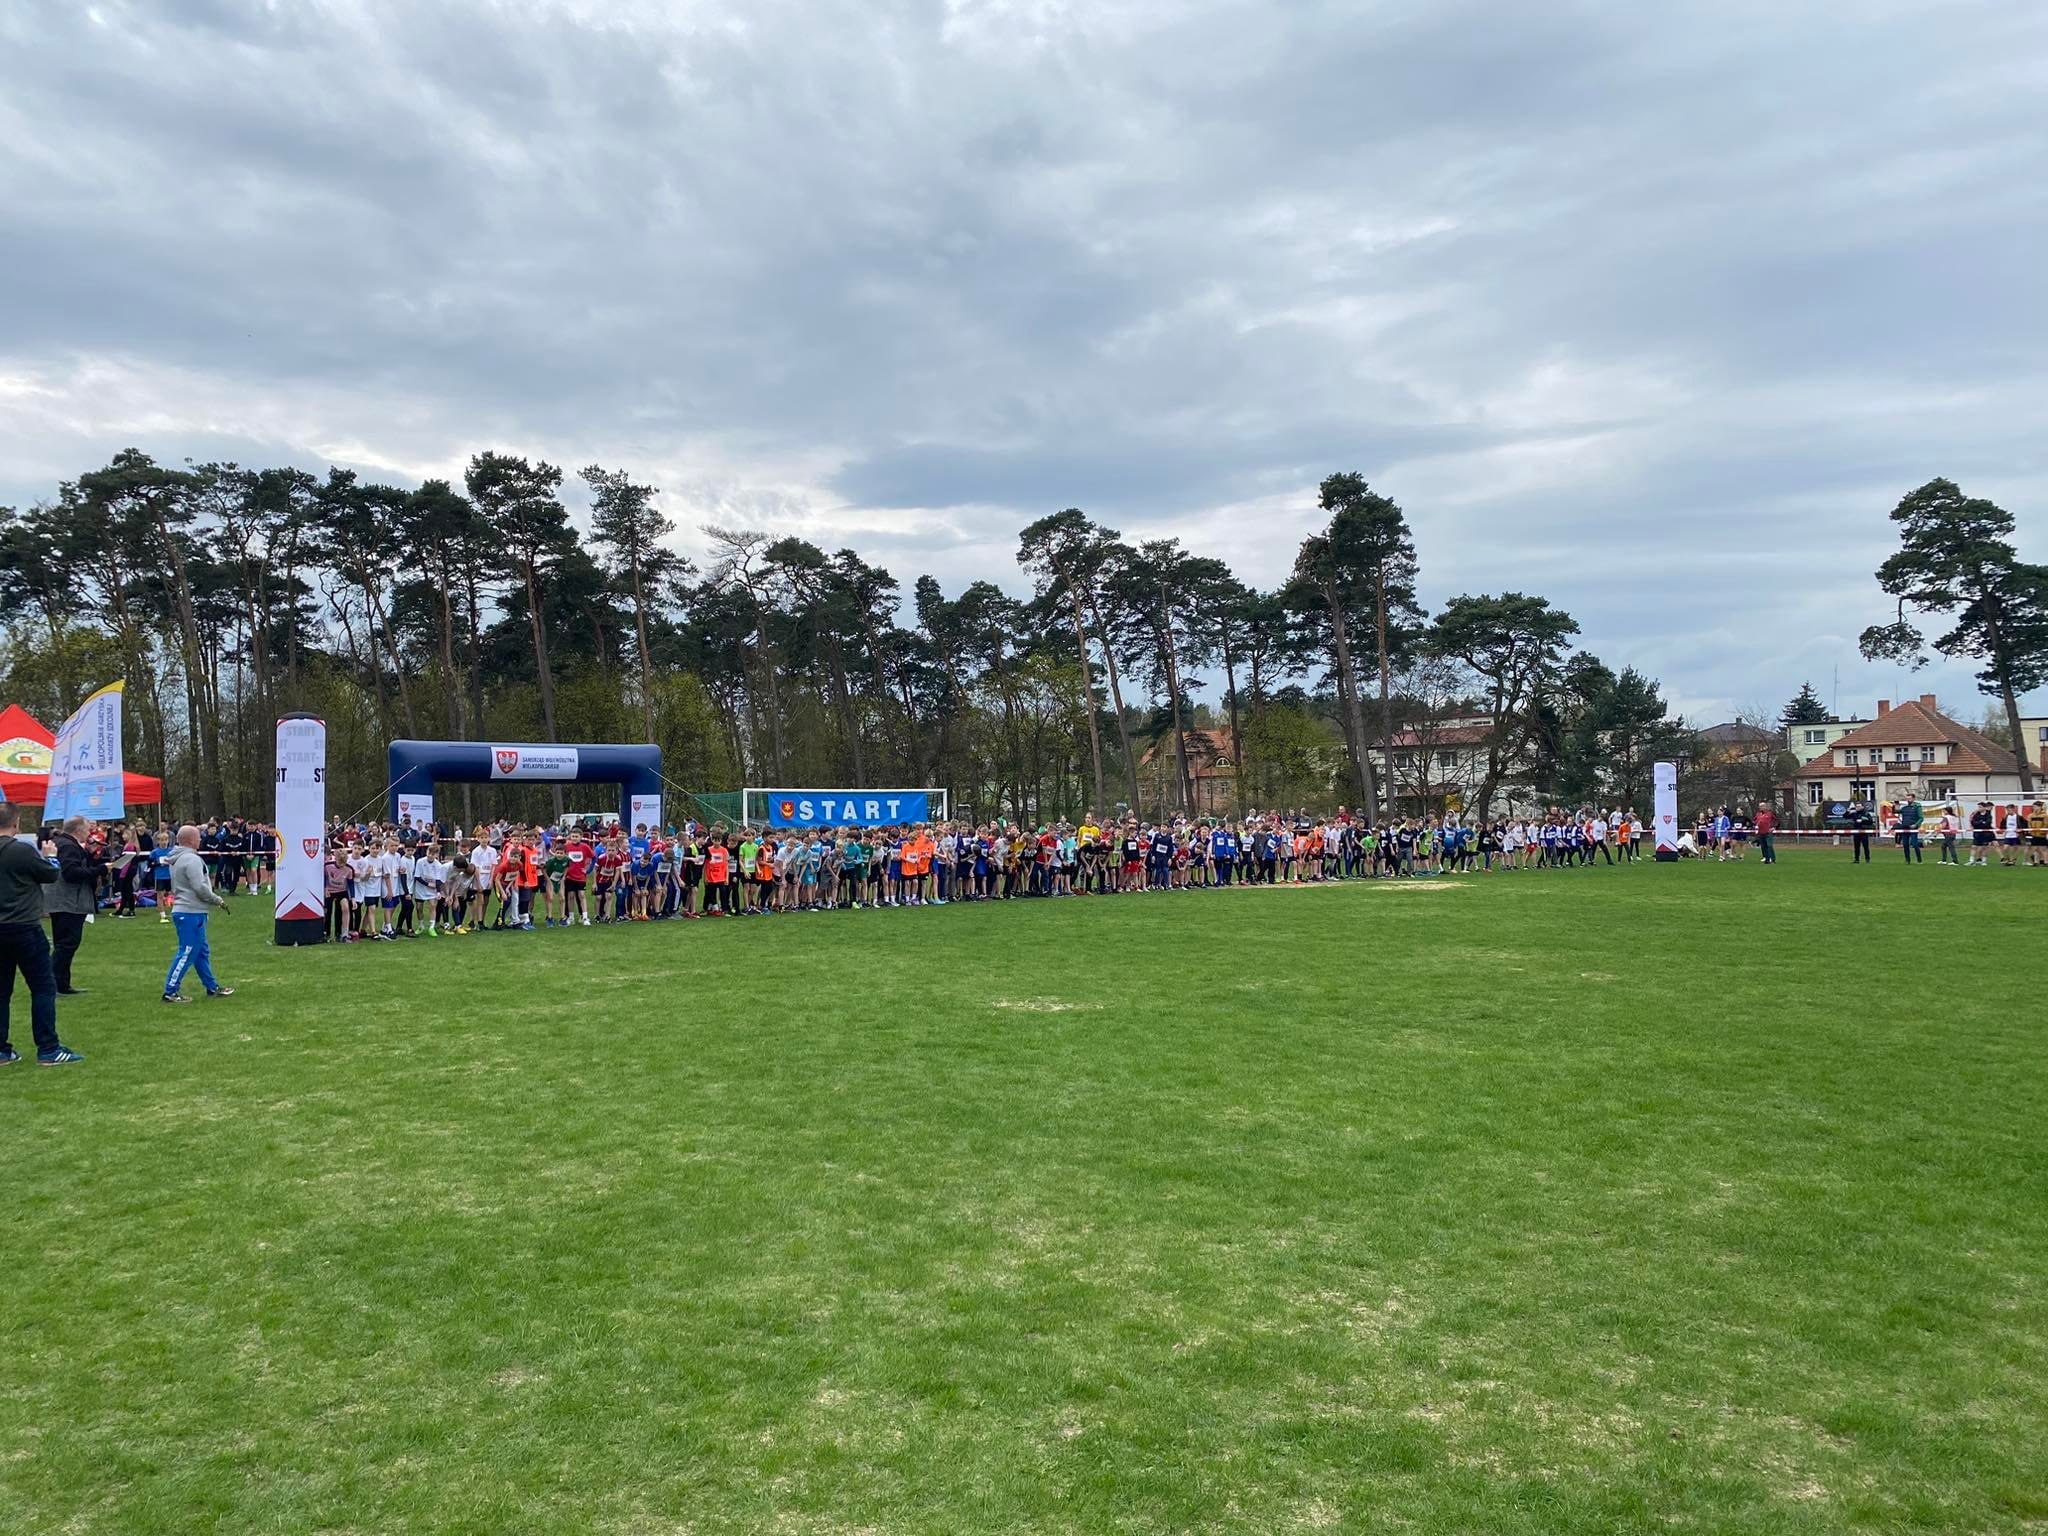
[0,0,2048,719]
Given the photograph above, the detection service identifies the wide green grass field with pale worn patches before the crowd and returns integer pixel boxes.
[0,854,2048,1536]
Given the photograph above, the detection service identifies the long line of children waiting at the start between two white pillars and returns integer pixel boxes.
[315,798,1640,940]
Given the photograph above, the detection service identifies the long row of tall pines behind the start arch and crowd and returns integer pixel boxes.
[0,449,1777,821]
